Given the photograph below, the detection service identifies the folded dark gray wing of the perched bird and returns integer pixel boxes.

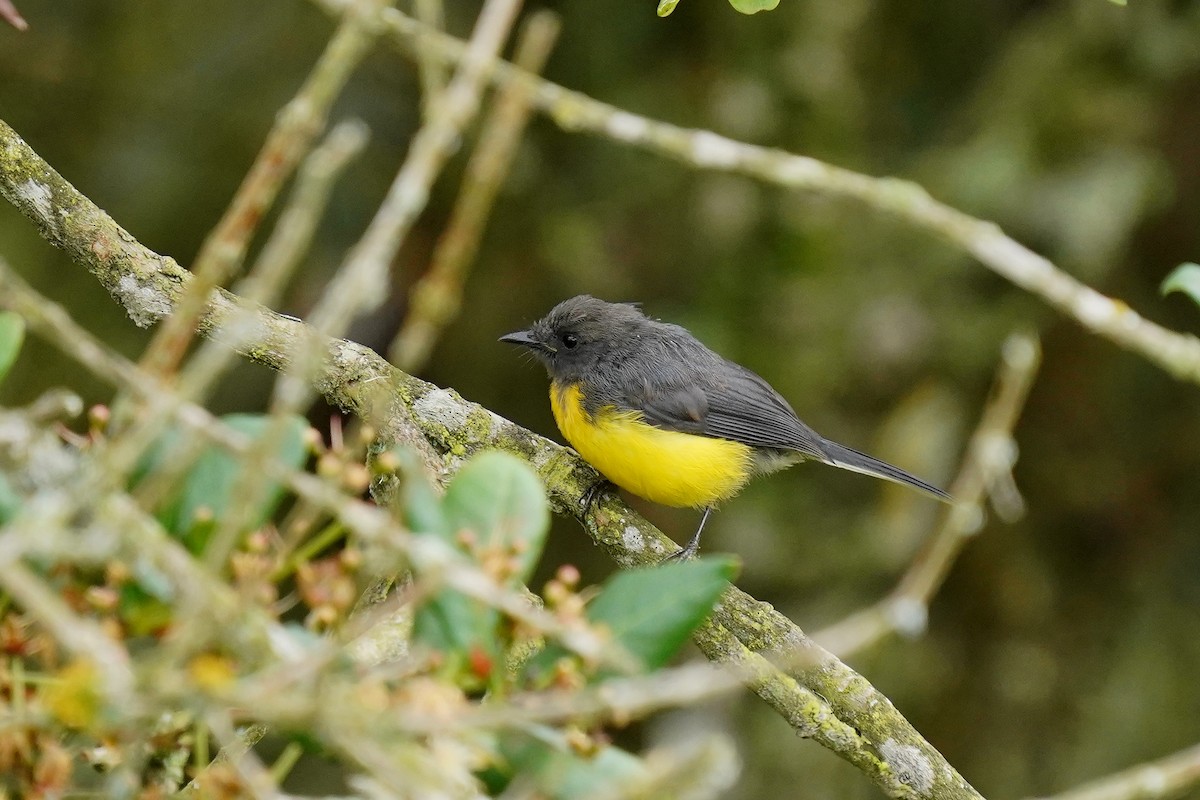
[636,359,828,461]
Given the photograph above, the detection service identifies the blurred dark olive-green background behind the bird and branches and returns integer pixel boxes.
[0,0,1200,798]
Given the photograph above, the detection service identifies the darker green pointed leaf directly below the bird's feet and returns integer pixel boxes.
[587,557,737,669]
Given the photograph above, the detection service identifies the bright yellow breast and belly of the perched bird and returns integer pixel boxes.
[550,385,754,507]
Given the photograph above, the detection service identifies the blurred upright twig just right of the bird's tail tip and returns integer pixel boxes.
[812,333,1040,657]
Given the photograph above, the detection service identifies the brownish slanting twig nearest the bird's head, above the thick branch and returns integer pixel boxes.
[388,11,559,373]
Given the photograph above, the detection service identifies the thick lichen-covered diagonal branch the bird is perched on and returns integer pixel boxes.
[0,115,979,800]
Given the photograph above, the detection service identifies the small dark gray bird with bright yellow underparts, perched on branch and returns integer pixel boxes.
[499,295,953,560]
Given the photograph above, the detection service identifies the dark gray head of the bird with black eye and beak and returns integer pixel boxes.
[500,295,649,380]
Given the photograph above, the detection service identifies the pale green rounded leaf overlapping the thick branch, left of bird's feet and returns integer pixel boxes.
[443,451,550,585]
